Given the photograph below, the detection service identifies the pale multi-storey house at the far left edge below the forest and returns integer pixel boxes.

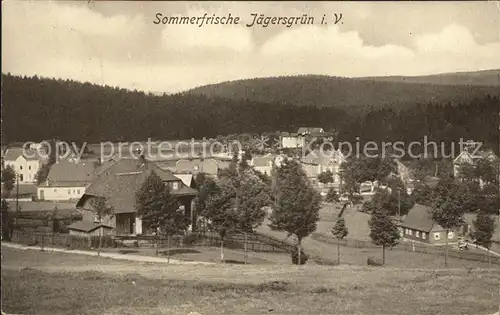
[3,148,43,184]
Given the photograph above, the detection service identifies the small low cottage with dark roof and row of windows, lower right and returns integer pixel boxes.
[400,204,458,245]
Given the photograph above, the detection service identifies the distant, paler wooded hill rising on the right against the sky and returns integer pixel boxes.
[184,74,500,109]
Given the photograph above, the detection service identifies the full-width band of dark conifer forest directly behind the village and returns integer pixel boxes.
[2,75,500,153]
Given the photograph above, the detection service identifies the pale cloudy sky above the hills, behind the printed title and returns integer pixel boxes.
[2,0,500,93]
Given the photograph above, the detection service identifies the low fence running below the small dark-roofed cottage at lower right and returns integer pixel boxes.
[312,233,500,265]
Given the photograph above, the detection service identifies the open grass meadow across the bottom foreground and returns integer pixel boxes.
[2,248,500,315]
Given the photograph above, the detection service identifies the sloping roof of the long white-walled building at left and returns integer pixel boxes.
[41,160,100,187]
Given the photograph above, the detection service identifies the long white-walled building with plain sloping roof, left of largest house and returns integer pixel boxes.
[37,159,101,200]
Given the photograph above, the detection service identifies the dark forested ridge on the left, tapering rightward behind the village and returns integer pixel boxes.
[2,75,349,142]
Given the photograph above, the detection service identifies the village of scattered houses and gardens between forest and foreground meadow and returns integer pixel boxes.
[2,127,500,266]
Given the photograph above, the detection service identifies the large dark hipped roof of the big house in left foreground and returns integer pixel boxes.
[77,159,196,213]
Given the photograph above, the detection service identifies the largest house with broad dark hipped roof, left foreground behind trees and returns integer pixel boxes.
[76,157,196,235]
